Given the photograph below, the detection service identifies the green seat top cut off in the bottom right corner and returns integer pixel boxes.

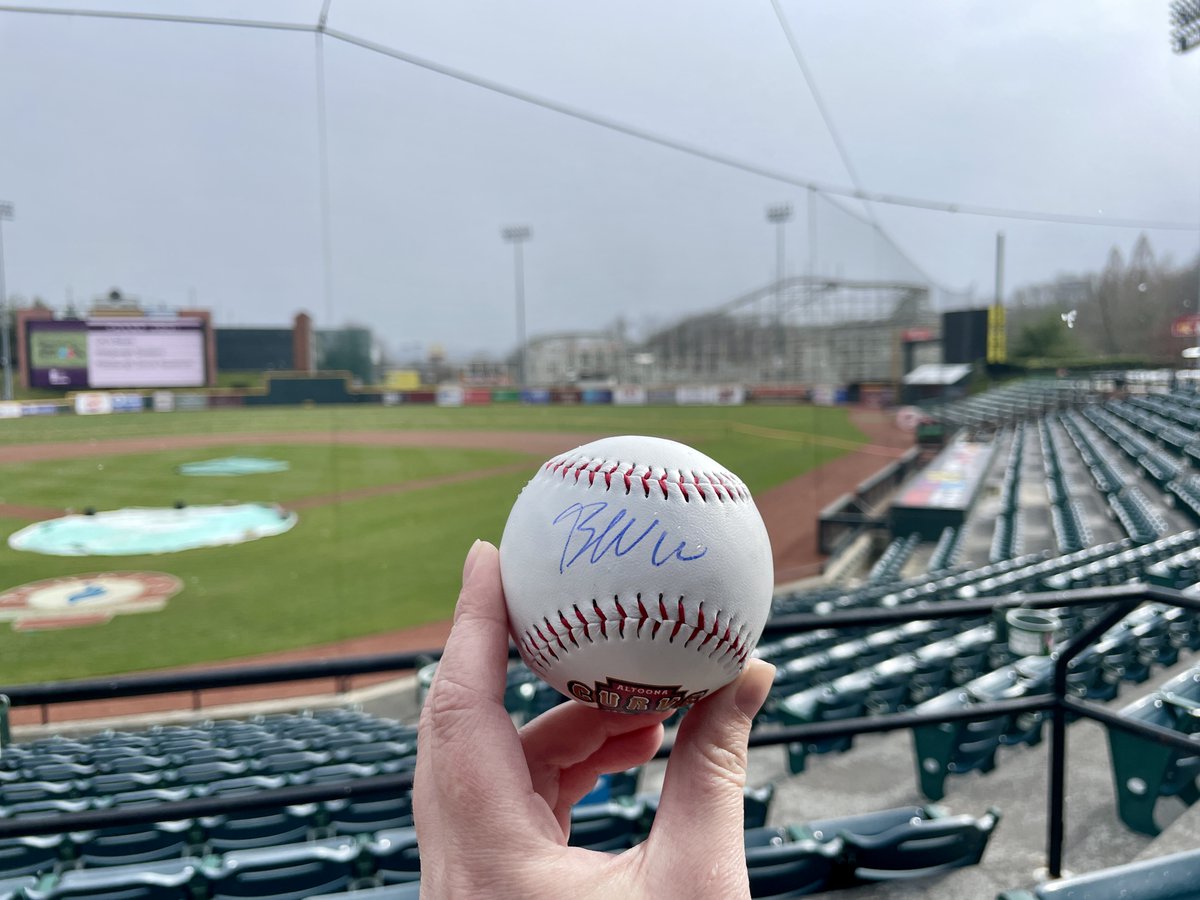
[996,850,1200,900]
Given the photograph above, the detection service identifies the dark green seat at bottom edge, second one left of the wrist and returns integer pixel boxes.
[205,838,361,900]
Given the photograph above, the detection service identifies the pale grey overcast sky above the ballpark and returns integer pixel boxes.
[0,0,1200,356]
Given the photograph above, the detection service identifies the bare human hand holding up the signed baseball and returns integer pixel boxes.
[413,541,773,900]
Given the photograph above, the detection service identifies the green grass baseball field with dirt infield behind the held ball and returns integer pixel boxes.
[0,407,884,684]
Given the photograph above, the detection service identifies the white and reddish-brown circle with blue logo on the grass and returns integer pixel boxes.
[0,572,184,631]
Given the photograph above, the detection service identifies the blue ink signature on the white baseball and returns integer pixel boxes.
[553,500,708,574]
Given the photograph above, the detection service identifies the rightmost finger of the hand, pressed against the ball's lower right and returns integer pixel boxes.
[652,660,775,868]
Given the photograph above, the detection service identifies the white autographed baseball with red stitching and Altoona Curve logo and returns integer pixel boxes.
[500,437,774,713]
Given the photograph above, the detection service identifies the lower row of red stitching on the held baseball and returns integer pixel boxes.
[520,594,754,672]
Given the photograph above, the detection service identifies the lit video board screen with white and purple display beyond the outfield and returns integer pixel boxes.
[26,317,206,389]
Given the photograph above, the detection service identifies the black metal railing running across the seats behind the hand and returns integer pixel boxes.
[0,582,1200,878]
